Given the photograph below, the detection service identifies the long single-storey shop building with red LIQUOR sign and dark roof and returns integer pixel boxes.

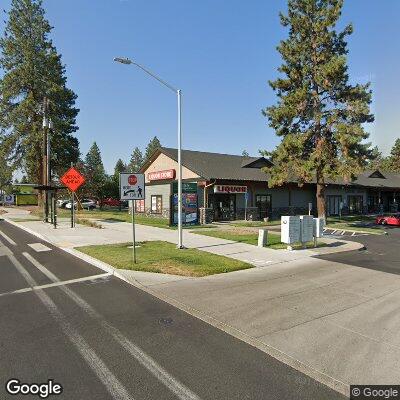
[136,147,400,223]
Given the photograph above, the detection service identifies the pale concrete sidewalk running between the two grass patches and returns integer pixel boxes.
[7,215,362,267]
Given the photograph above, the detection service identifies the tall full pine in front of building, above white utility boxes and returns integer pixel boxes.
[263,0,374,218]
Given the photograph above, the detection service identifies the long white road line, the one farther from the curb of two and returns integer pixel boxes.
[9,256,133,400]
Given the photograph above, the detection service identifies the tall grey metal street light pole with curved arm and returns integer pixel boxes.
[114,57,184,249]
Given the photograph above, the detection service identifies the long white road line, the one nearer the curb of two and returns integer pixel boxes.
[23,253,200,400]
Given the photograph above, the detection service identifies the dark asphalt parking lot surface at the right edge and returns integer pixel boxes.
[318,227,400,274]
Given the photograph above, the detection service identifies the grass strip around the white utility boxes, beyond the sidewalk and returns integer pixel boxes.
[196,229,326,250]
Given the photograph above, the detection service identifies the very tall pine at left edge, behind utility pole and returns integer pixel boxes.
[0,0,79,183]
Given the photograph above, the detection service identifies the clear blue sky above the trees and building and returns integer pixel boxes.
[0,0,400,171]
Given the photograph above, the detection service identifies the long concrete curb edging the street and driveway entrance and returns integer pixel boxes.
[5,218,350,396]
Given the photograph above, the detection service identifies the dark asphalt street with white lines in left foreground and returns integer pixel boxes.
[0,220,344,400]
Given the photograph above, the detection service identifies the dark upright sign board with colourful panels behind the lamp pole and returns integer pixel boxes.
[171,182,198,225]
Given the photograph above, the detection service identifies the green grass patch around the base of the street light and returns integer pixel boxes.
[77,241,253,276]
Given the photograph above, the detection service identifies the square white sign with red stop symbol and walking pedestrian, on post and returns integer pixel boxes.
[119,172,145,264]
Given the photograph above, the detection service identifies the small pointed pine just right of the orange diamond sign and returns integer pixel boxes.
[83,142,107,200]
